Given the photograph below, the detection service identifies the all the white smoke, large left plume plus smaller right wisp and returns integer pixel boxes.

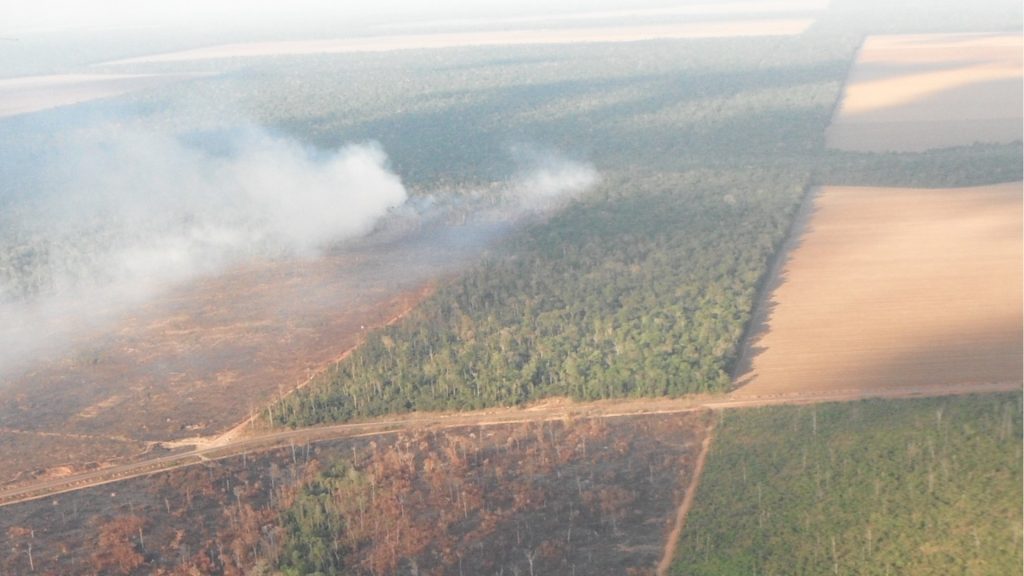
[0,125,598,376]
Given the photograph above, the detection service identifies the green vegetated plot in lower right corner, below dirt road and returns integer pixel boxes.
[673,393,1024,576]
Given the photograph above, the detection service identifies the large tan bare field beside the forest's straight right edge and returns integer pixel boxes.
[737,182,1024,396]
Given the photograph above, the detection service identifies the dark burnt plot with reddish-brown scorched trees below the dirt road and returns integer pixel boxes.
[0,411,714,575]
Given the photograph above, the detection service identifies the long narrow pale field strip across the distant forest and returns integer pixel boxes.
[103,18,813,66]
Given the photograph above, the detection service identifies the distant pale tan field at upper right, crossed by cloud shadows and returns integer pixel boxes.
[826,34,1024,152]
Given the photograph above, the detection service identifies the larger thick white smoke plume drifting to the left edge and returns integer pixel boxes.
[0,129,407,372]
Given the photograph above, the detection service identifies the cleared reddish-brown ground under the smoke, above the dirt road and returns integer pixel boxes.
[0,245,436,484]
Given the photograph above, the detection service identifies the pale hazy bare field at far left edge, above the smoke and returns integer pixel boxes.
[0,74,193,118]
